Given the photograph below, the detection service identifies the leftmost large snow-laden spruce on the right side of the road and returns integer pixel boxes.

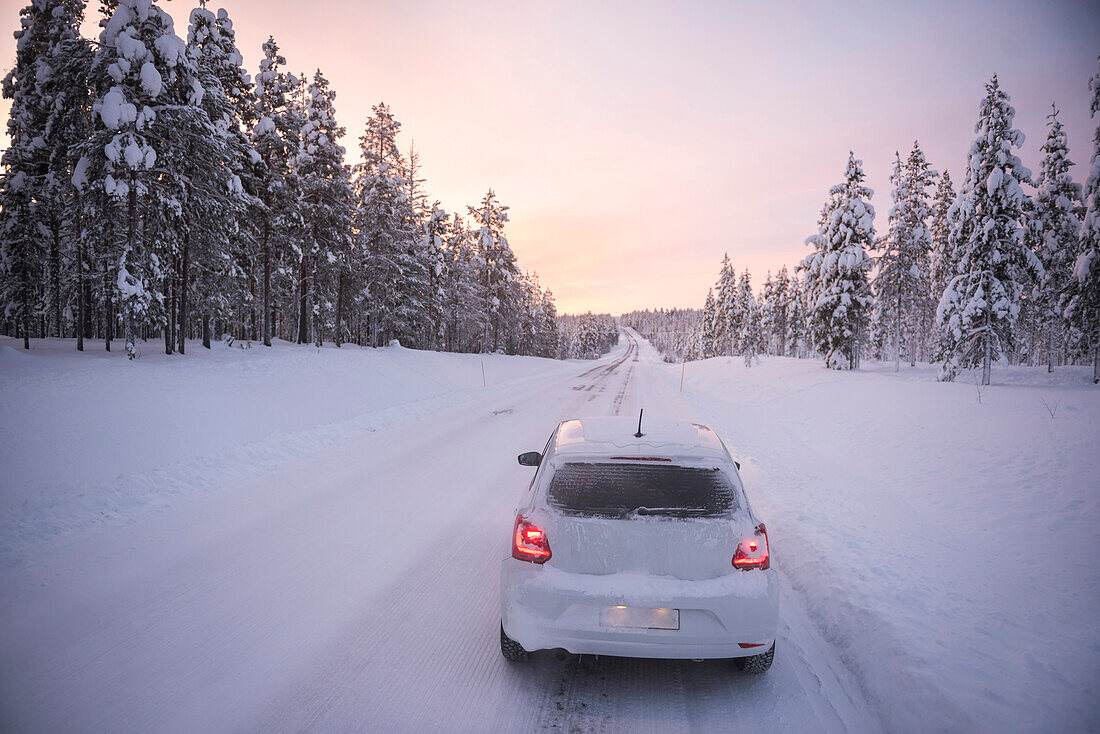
[799,153,875,370]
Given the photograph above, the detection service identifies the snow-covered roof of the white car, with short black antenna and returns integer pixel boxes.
[556,417,726,458]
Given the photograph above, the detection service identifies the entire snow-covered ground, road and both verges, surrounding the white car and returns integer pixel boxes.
[0,332,1100,732]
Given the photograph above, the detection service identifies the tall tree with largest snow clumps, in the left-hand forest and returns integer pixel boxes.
[74,0,209,359]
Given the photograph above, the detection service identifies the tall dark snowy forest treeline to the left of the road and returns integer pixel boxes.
[0,0,589,357]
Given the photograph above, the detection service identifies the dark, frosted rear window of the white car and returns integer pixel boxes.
[547,462,736,517]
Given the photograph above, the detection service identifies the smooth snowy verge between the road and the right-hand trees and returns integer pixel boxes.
[663,358,1100,731]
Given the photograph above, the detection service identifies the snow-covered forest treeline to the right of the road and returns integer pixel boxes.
[624,66,1100,384]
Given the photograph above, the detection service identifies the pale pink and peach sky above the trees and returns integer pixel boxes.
[0,0,1100,314]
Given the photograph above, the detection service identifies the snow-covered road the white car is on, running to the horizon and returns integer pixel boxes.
[0,335,883,732]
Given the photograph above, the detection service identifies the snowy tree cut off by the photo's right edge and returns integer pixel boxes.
[1063,57,1100,383]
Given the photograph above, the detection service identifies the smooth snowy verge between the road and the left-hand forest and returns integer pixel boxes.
[0,338,587,567]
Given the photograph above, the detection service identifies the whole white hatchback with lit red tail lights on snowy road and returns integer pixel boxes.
[501,418,779,672]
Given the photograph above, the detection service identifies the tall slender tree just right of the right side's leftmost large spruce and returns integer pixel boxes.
[873,142,936,371]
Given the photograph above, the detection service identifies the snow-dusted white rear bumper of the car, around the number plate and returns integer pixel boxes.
[501,558,779,658]
